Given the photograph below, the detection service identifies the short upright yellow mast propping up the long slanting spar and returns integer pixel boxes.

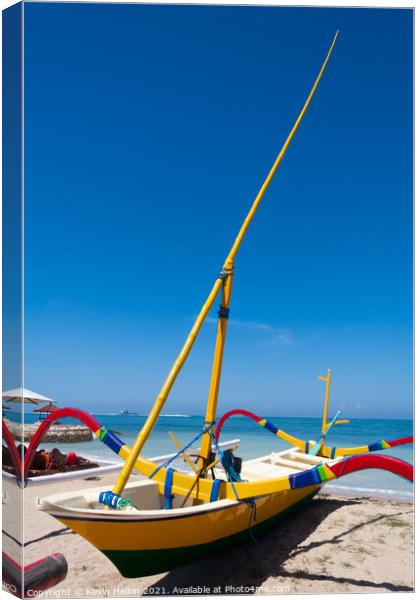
[200,262,233,469]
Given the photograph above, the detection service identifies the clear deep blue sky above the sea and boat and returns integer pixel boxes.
[21,3,413,418]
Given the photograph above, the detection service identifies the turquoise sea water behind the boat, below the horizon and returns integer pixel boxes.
[7,411,413,499]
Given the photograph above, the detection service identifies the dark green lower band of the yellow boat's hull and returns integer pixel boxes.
[101,490,318,577]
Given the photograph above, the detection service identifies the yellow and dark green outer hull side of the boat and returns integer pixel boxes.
[54,486,320,578]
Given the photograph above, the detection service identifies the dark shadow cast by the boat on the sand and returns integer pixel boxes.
[150,497,413,594]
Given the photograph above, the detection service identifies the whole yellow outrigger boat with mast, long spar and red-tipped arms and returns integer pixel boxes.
[37,32,413,577]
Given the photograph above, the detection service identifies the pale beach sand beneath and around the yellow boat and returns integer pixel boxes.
[3,474,413,598]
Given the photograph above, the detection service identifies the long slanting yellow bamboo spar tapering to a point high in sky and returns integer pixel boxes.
[113,31,338,494]
